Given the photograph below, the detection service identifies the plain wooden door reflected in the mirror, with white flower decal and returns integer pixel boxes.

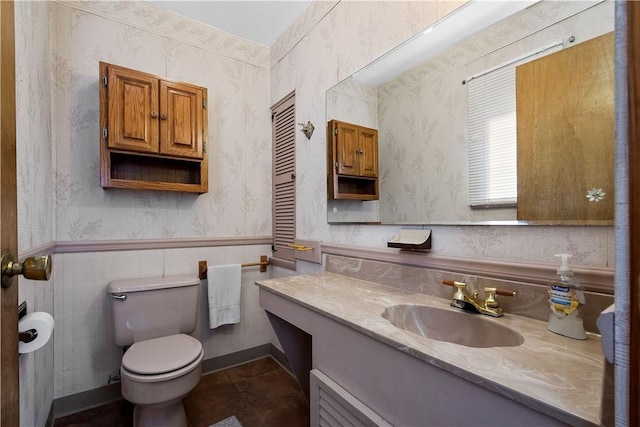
[516,33,615,221]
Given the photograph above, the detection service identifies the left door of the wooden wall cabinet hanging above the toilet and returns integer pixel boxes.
[107,65,158,153]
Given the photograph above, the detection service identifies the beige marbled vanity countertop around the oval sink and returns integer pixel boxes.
[256,272,604,425]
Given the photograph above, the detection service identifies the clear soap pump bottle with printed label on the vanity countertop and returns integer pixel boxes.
[547,254,587,340]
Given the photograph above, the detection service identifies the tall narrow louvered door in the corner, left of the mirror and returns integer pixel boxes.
[271,93,296,261]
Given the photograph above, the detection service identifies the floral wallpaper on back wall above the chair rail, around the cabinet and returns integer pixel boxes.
[52,1,271,241]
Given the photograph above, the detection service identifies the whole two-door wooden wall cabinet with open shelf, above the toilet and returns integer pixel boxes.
[100,62,208,193]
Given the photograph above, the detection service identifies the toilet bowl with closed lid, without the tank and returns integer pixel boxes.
[120,334,204,427]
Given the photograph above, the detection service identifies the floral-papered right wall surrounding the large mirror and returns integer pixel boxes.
[271,1,614,267]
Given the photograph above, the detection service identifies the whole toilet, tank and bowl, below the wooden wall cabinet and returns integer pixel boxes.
[108,276,204,427]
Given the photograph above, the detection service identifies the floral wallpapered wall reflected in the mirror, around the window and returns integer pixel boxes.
[378,2,614,223]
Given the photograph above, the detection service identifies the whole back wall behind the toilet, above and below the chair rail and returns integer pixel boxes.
[45,1,271,398]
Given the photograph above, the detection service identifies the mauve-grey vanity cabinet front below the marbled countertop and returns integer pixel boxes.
[256,282,568,427]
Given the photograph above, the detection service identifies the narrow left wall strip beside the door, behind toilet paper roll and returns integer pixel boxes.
[14,2,55,426]
